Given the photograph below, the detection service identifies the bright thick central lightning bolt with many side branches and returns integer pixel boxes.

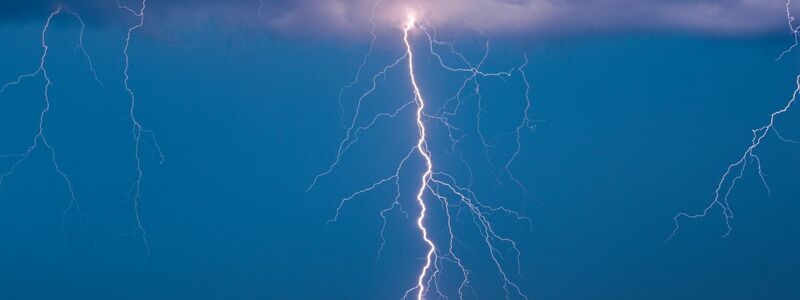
[307,1,535,300]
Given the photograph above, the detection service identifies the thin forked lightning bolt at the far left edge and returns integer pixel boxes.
[0,5,103,249]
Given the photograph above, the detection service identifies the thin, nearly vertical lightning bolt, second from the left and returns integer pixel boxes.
[117,0,164,257]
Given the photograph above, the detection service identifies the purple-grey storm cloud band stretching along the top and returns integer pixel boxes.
[0,0,800,35]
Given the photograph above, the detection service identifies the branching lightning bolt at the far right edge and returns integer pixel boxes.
[667,0,800,241]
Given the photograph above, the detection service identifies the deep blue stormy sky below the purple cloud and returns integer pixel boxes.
[0,2,800,299]
